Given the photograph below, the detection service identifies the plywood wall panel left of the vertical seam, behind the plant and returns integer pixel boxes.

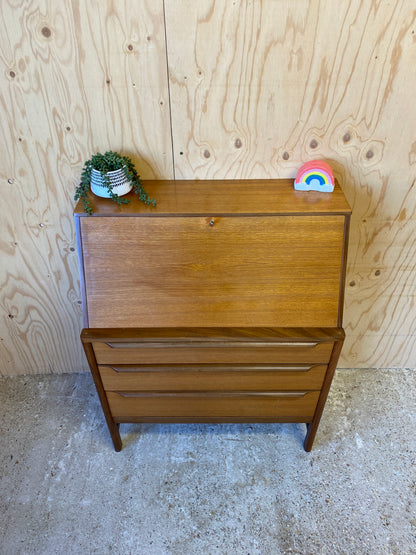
[0,0,172,375]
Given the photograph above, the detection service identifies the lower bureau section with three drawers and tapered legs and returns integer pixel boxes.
[81,328,344,451]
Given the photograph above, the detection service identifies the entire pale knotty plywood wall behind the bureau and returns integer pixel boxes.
[0,0,416,375]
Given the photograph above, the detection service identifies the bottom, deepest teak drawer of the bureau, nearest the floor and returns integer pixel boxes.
[107,391,320,422]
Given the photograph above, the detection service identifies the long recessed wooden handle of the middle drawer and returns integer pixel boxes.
[101,364,319,374]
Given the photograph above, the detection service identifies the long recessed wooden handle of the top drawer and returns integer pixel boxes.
[106,341,318,349]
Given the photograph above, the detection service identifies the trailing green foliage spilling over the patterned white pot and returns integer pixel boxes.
[74,150,156,215]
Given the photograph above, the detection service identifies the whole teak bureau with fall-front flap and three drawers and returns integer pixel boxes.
[75,179,351,451]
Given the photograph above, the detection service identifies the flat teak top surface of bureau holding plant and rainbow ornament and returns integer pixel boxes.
[75,179,351,217]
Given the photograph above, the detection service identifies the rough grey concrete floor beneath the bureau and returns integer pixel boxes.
[0,370,416,555]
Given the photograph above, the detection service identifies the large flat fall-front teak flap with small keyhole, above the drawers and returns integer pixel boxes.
[81,215,344,327]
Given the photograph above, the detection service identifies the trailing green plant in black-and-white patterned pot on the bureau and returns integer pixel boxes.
[74,150,156,215]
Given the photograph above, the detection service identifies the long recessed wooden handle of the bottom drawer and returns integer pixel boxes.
[114,391,309,399]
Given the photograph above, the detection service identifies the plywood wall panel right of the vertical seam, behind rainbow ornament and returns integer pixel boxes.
[166,0,416,367]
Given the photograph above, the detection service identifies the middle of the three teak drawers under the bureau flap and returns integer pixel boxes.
[99,364,327,391]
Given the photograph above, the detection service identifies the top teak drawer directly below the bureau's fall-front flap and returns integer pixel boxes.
[93,341,333,365]
